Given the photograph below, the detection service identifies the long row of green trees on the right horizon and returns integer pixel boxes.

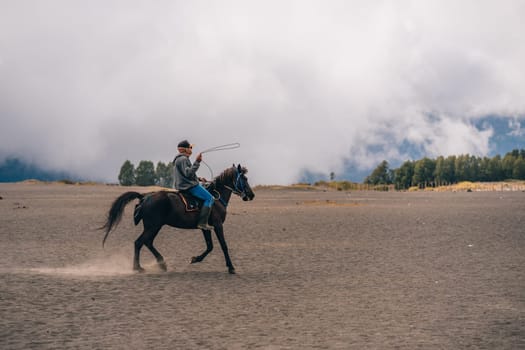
[364,149,525,190]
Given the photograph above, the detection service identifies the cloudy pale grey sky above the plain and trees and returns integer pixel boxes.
[0,0,525,184]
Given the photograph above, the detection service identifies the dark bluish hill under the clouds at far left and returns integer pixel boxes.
[0,158,78,182]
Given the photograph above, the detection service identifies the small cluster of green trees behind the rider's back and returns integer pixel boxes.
[118,160,173,187]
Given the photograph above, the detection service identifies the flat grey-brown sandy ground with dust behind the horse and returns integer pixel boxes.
[0,184,525,349]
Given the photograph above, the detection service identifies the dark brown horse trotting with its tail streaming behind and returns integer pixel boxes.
[100,164,255,274]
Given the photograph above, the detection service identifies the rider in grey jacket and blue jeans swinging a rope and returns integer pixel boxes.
[173,140,214,231]
